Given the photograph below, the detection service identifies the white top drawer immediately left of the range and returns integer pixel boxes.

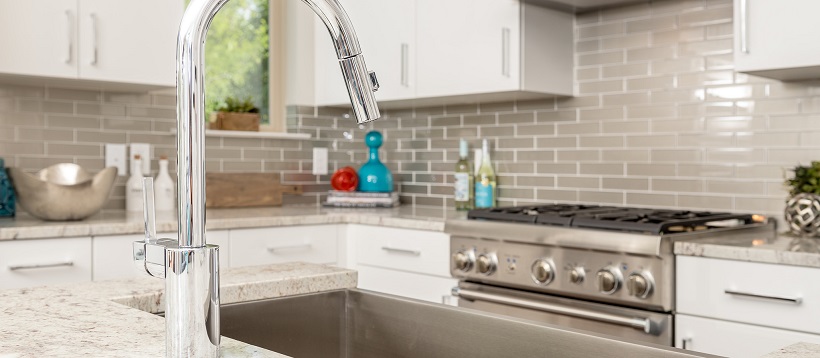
[348,225,450,277]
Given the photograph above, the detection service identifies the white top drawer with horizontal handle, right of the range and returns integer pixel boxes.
[676,256,820,333]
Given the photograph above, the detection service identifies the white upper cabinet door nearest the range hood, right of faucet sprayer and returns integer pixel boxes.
[416,0,521,98]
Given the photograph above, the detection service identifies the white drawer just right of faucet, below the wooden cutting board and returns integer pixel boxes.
[230,225,337,267]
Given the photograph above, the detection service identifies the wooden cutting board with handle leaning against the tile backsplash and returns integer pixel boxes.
[205,173,302,208]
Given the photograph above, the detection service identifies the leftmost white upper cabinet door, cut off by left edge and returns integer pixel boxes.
[0,0,78,78]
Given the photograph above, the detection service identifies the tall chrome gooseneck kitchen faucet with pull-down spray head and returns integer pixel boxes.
[134,0,379,357]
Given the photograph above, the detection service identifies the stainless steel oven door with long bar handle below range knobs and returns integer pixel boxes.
[453,281,673,346]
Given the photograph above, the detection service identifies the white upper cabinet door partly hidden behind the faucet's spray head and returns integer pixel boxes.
[316,0,416,105]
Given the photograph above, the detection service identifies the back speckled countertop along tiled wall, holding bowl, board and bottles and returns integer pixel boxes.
[0,205,466,241]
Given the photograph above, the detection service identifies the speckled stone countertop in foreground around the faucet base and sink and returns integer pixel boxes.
[0,263,357,358]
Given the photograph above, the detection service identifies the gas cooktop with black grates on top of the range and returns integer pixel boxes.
[467,204,756,234]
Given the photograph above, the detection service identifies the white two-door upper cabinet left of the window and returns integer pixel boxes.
[0,0,183,87]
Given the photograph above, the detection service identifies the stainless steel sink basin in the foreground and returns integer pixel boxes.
[221,289,714,358]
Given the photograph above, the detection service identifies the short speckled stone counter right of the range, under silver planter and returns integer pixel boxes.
[675,234,820,268]
